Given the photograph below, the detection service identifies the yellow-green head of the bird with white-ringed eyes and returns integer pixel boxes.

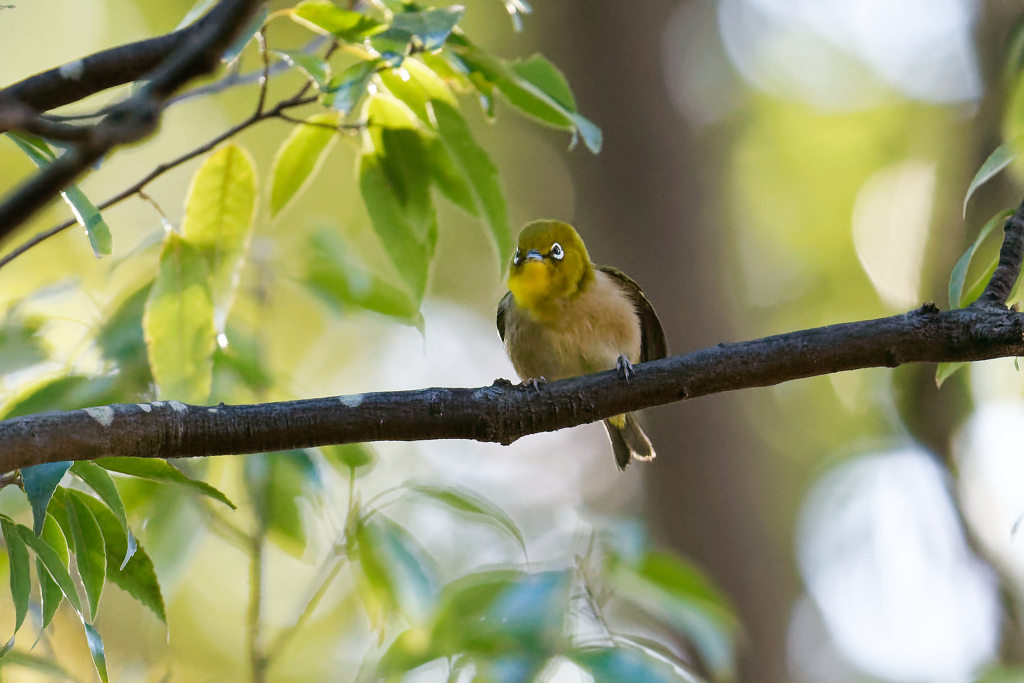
[509,220,594,312]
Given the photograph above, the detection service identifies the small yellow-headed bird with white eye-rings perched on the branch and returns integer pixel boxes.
[498,220,668,470]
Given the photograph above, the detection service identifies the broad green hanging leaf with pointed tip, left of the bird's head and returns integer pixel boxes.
[359,148,437,308]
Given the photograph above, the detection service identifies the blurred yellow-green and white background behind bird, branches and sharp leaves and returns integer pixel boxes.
[0,0,1024,683]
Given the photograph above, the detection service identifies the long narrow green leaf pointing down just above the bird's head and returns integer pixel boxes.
[430,100,515,270]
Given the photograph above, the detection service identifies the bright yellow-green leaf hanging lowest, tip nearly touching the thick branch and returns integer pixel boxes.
[142,232,216,403]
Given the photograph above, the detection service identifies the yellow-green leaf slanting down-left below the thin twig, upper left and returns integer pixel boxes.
[270,112,339,216]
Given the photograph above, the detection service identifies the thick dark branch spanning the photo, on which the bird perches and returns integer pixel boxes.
[0,304,1024,471]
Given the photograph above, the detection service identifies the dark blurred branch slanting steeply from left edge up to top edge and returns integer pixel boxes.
[0,0,260,240]
